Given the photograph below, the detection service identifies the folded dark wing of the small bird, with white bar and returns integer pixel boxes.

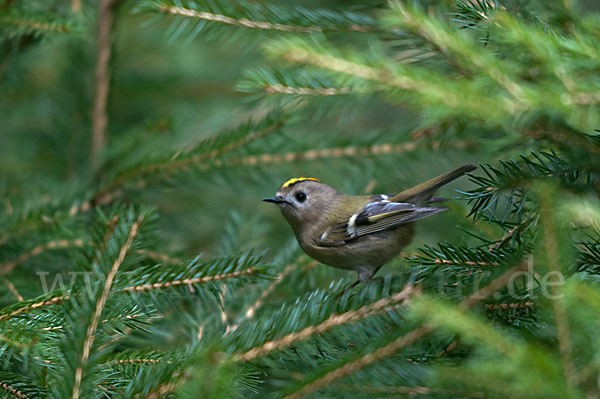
[318,195,448,246]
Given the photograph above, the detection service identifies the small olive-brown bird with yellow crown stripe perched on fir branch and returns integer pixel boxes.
[263,164,477,284]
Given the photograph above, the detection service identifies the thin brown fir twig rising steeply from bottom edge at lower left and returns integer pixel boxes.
[72,216,143,399]
